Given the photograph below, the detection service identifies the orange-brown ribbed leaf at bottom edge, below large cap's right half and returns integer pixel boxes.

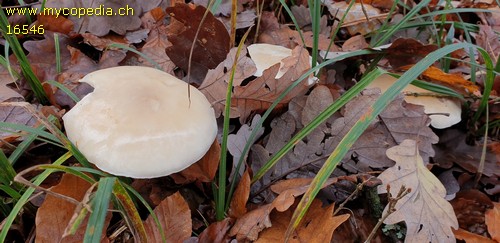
[144,192,192,242]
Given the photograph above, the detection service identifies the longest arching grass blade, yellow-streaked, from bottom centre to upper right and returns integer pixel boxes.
[285,43,474,239]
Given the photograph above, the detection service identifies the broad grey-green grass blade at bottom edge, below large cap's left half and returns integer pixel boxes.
[83,177,116,243]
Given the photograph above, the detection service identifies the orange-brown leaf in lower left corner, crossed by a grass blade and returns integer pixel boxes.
[35,174,111,243]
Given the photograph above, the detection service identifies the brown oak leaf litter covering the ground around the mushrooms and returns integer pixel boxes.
[0,0,500,242]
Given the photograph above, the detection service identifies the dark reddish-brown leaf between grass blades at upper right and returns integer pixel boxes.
[386,38,438,68]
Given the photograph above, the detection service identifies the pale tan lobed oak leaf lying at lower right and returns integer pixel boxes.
[378,139,458,242]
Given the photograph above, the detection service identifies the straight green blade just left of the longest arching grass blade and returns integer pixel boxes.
[252,68,385,183]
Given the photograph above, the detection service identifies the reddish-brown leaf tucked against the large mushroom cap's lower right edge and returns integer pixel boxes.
[170,140,220,184]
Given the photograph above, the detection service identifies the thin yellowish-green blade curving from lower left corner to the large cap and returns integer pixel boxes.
[0,153,71,242]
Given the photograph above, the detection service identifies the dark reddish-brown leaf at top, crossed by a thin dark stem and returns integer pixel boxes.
[166,4,229,83]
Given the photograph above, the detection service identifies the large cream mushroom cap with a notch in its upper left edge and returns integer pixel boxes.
[63,66,217,178]
